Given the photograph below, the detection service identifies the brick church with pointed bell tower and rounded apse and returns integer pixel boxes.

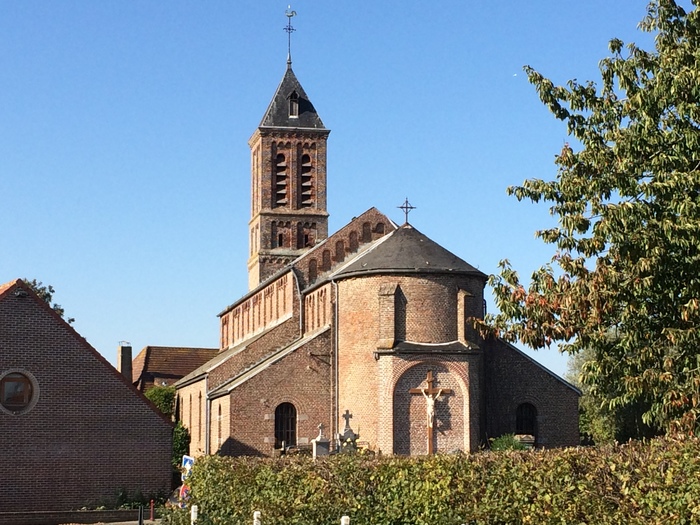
[176,55,580,456]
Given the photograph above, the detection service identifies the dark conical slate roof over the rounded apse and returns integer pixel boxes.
[334,223,486,279]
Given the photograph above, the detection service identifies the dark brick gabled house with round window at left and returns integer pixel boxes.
[0,280,172,512]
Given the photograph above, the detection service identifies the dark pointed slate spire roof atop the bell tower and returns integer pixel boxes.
[260,65,325,129]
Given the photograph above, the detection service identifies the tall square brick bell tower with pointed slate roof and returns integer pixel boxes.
[248,57,330,290]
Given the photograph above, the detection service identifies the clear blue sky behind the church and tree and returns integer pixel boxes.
[0,0,672,374]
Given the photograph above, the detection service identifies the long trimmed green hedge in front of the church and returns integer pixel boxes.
[165,439,700,525]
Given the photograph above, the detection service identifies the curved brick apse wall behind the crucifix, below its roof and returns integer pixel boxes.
[337,275,482,453]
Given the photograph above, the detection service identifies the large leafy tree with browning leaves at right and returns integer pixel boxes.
[477,0,700,431]
